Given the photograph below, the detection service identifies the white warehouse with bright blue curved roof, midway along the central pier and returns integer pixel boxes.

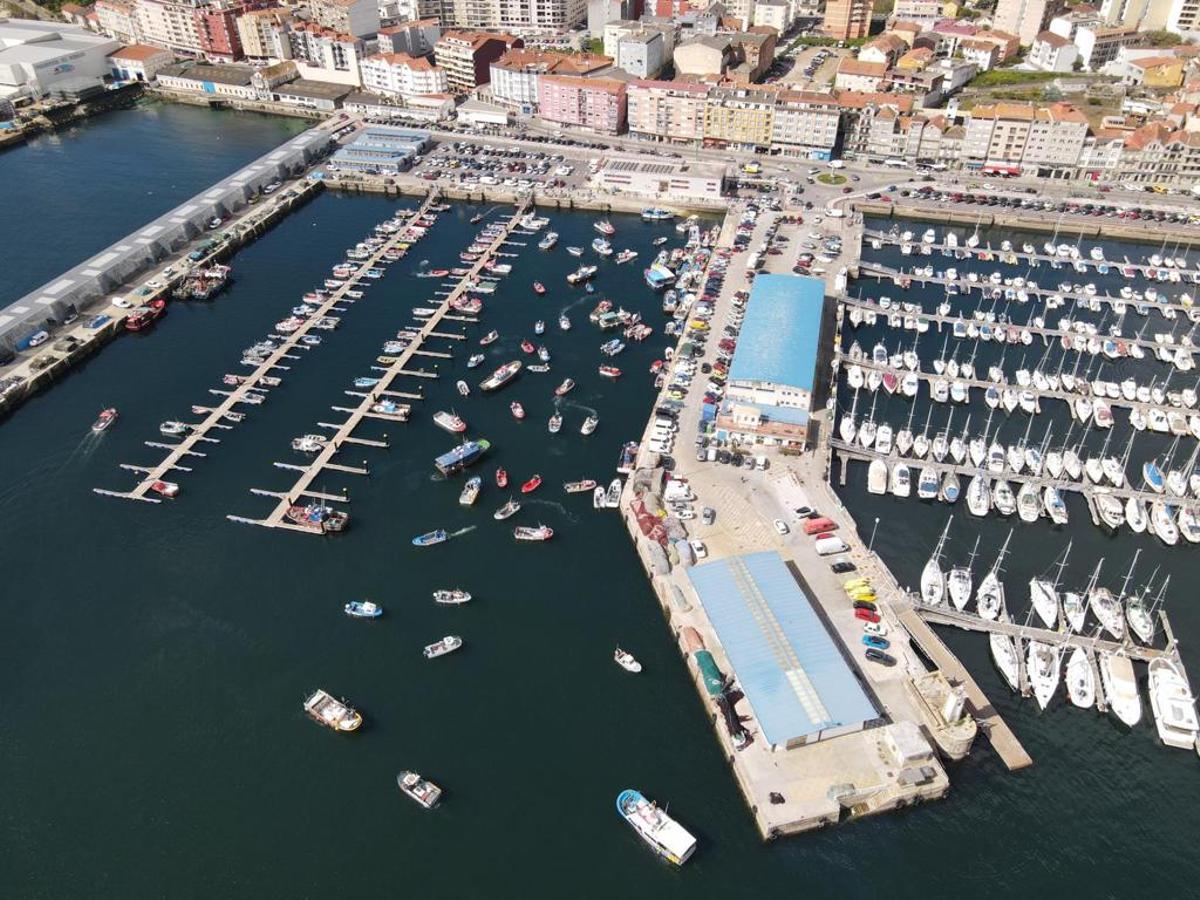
[718,275,834,444]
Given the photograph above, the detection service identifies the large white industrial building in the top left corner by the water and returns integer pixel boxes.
[0,18,121,102]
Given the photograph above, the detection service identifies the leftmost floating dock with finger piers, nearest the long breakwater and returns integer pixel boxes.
[94,188,438,500]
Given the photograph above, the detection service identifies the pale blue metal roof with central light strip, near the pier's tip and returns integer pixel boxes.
[688,551,878,745]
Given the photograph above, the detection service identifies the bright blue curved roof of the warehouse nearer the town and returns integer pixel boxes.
[730,275,824,390]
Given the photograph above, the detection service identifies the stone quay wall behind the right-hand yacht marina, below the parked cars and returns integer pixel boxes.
[852,200,1196,244]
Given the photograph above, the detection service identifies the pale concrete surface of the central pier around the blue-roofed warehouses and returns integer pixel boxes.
[622,200,1030,840]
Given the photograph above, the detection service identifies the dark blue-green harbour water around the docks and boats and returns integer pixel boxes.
[0,107,1200,898]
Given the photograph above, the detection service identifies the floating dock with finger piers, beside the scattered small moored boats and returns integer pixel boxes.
[227,203,529,534]
